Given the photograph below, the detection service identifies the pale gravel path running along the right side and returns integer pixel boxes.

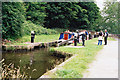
[84,40,118,78]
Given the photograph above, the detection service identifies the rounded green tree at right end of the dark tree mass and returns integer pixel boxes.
[77,2,100,30]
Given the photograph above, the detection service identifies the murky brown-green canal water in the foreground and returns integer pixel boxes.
[2,48,66,78]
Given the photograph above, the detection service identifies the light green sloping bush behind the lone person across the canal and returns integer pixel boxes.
[22,21,58,35]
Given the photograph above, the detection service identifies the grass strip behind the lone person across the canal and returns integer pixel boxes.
[7,34,60,45]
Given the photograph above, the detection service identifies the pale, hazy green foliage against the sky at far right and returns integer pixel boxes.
[102,2,120,34]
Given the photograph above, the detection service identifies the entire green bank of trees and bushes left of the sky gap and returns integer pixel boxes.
[2,2,100,39]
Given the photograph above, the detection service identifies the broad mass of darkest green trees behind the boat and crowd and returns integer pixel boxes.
[45,2,100,30]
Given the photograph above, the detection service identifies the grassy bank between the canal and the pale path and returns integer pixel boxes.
[49,38,115,78]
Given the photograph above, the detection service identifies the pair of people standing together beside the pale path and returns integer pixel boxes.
[98,29,108,45]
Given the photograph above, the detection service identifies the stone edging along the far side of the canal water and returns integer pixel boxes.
[2,39,73,51]
